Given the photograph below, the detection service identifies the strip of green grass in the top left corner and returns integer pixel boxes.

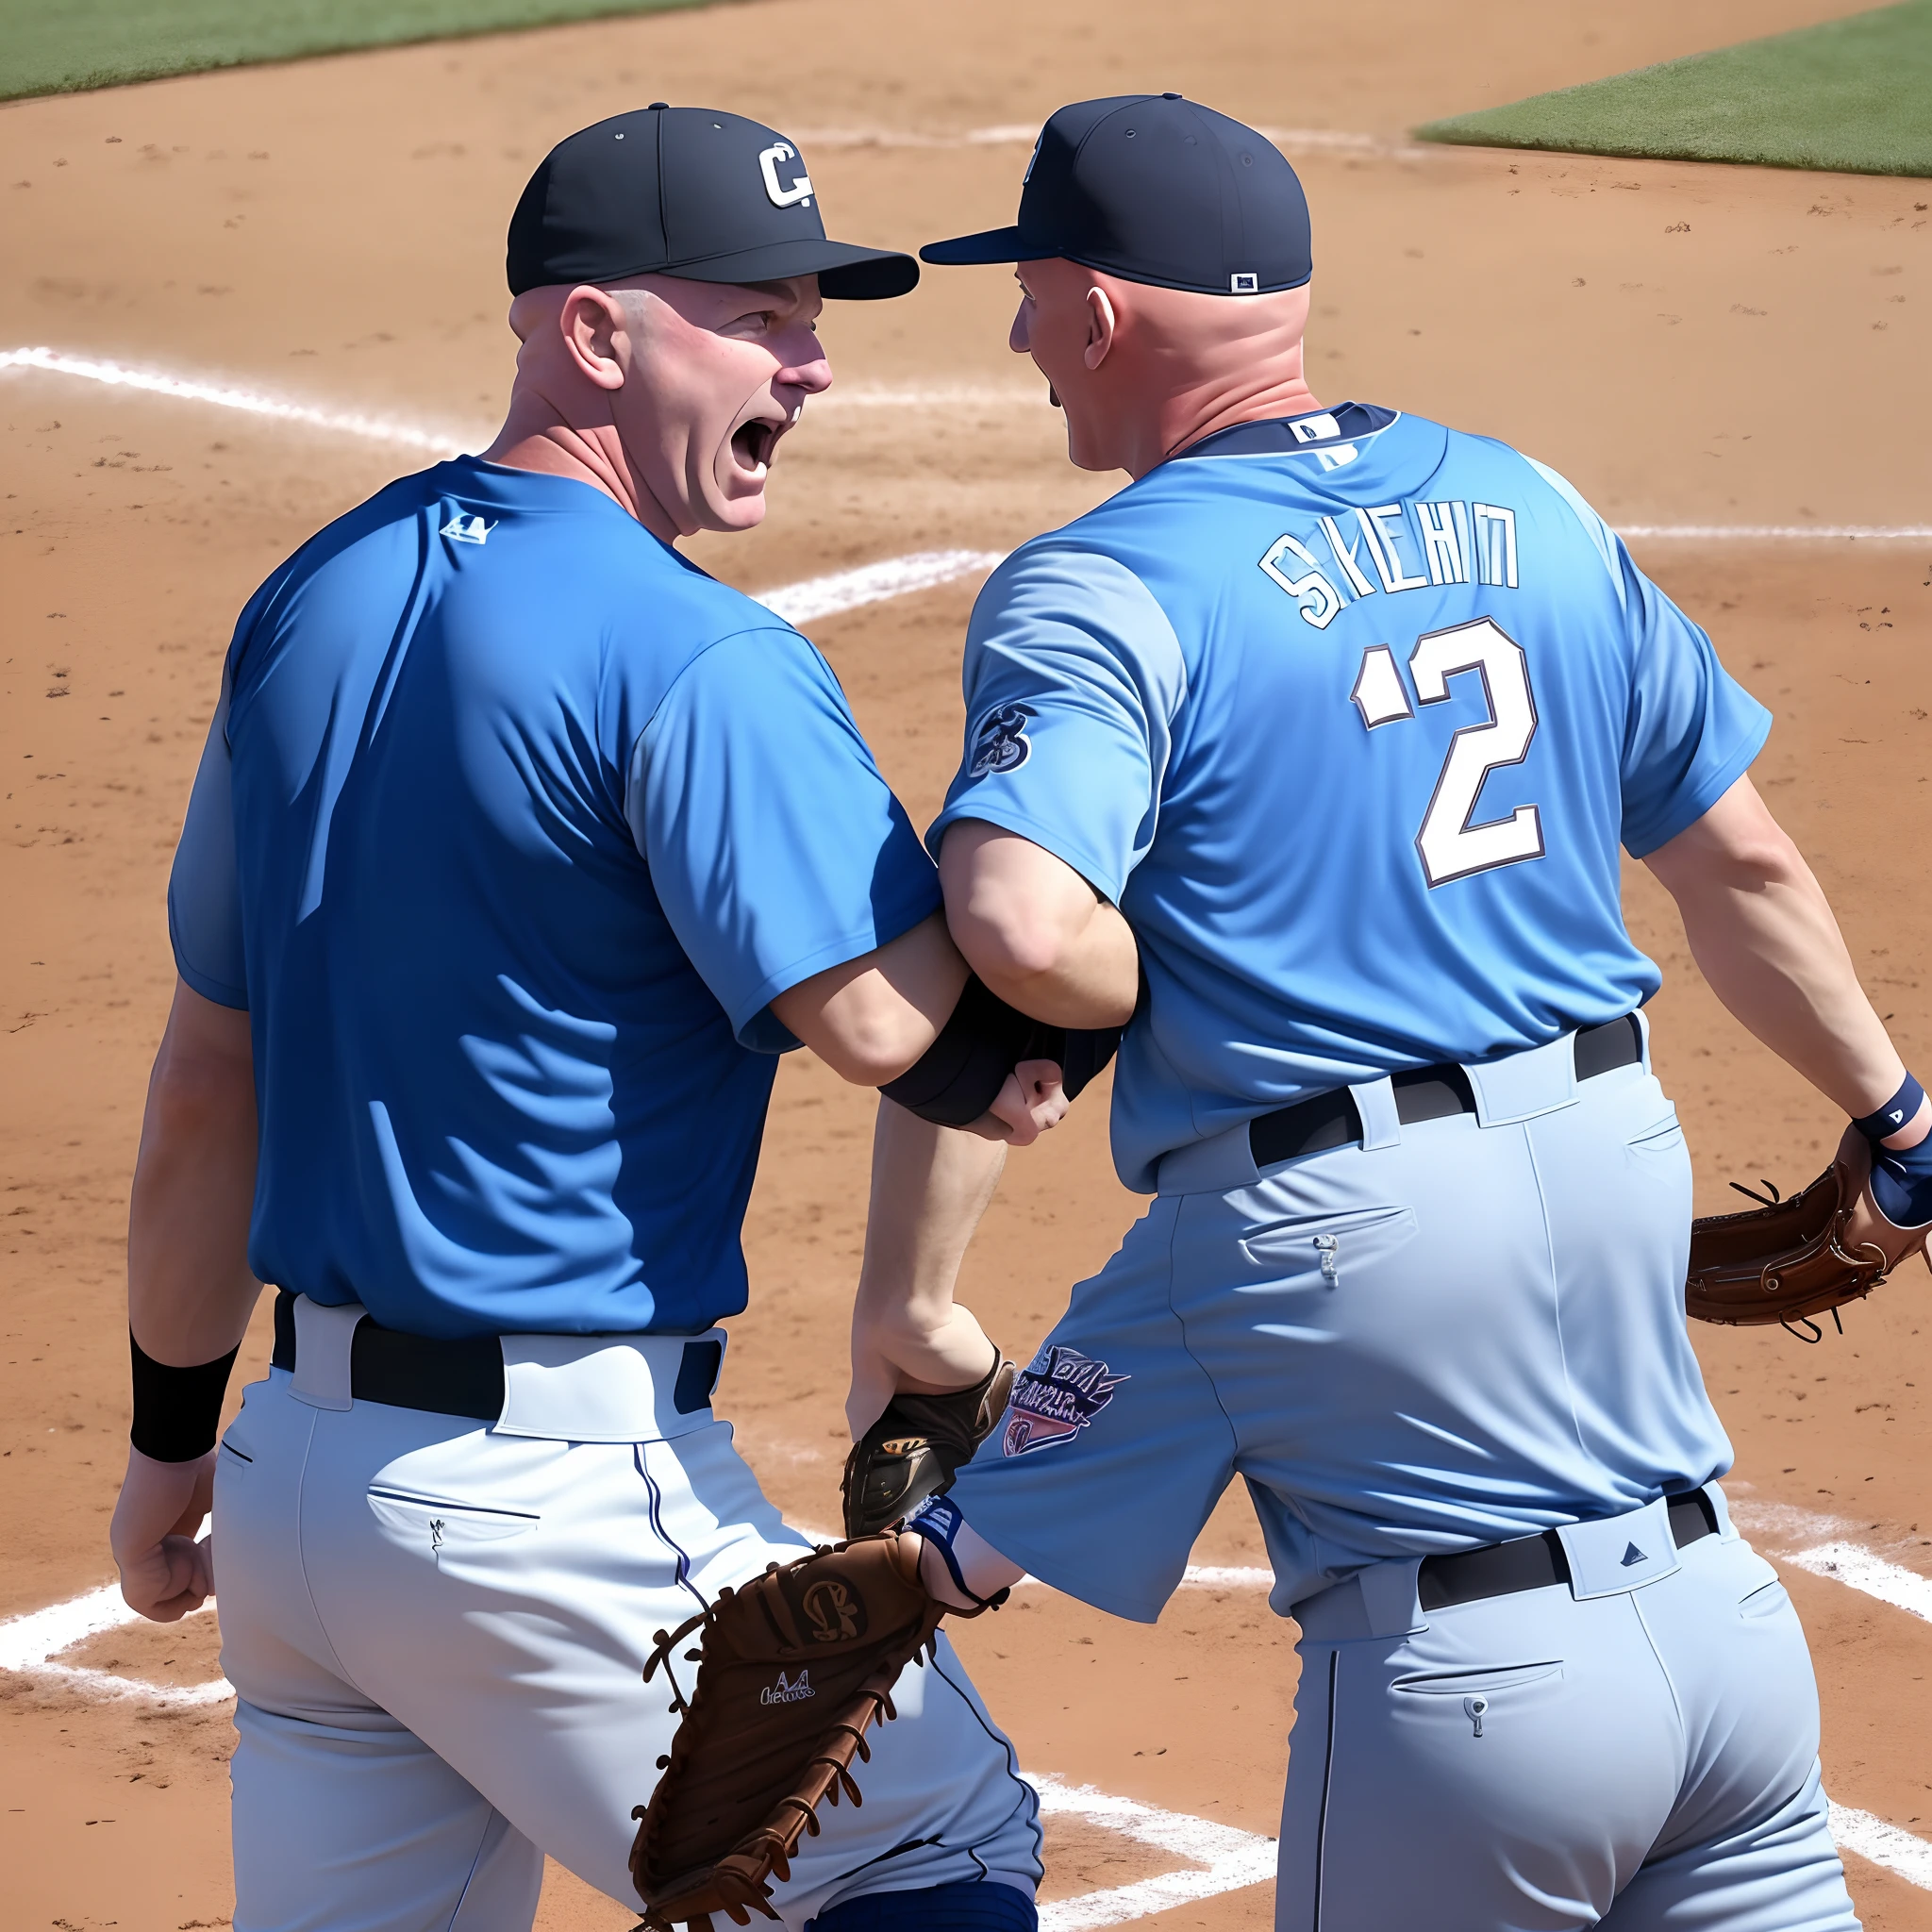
[0,0,722,100]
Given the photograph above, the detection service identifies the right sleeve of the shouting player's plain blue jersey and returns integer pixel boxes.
[625,626,939,1053]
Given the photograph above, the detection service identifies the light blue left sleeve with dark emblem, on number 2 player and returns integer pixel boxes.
[925,545,1186,902]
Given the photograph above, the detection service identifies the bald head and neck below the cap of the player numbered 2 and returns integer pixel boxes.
[1008,257,1320,477]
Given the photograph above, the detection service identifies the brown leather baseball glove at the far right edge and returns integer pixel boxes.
[1685,1159,1891,1341]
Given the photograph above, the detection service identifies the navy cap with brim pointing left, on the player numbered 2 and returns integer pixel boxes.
[920,94,1314,295]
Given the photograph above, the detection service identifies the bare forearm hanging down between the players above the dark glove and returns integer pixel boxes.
[846,1099,1007,1438]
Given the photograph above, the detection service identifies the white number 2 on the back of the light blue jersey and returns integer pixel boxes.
[1349,616,1543,887]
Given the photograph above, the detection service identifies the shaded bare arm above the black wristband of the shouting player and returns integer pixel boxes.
[127,985,260,1368]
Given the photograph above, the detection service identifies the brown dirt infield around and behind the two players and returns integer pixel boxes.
[0,0,1932,1932]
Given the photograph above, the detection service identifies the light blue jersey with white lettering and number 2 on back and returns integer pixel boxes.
[927,404,1770,1192]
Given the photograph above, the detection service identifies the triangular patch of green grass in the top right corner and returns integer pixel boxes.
[1416,0,1932,174]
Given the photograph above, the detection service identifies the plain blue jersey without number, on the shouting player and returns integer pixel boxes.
[168,458,939,1335]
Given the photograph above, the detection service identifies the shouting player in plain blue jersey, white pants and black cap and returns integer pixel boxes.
[114,105,1062,1932]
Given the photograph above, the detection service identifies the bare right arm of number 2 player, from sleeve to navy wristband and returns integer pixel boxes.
[1648,778,1905,1115]
